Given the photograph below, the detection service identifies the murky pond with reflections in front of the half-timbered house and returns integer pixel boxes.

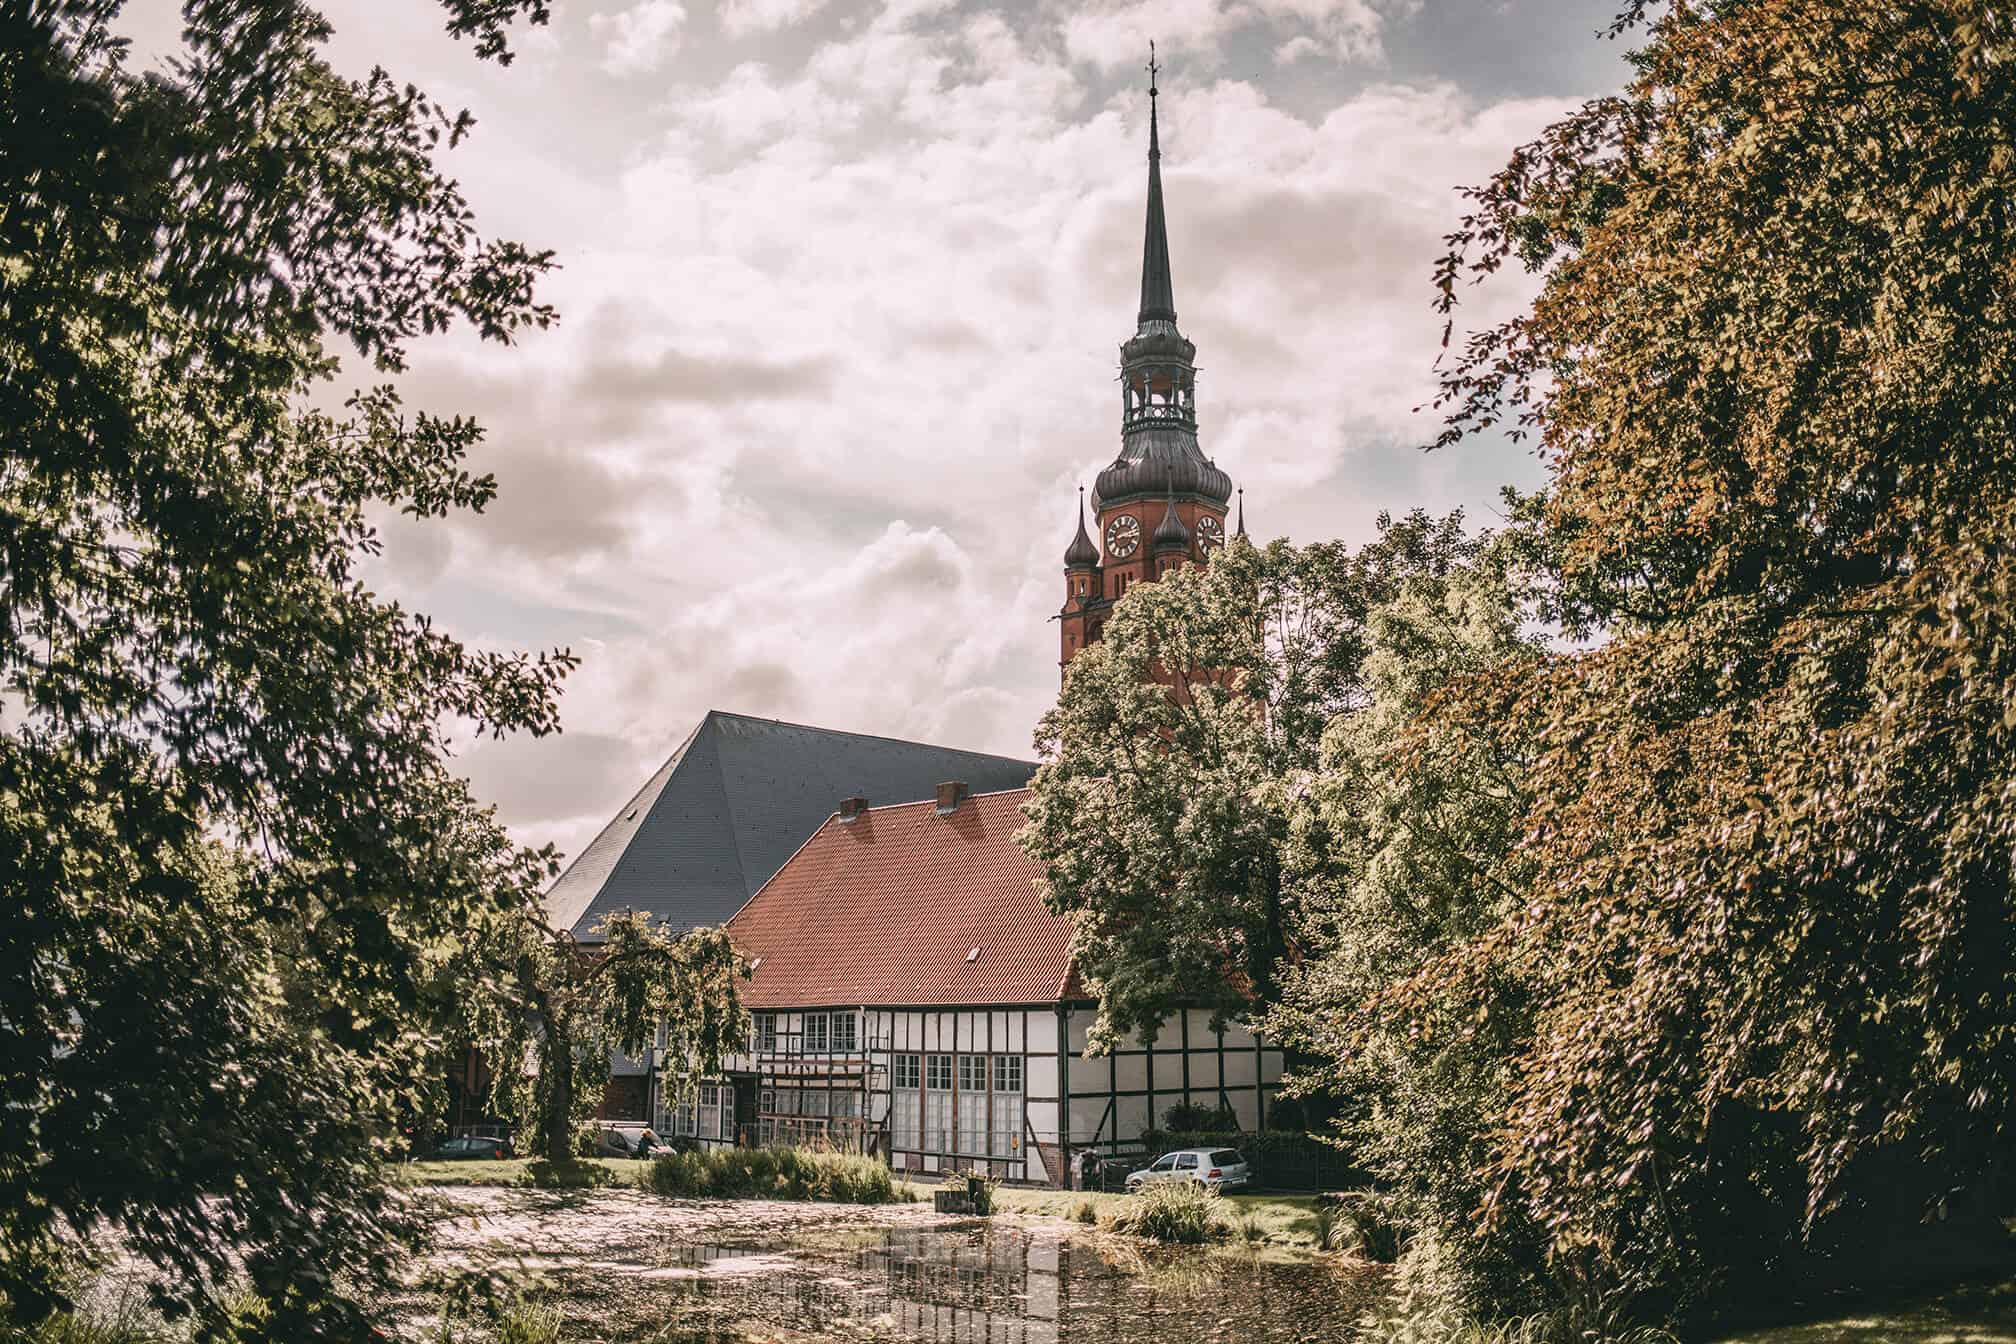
[425,1193,1385,1344]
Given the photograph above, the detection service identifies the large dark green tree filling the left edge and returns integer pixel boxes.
[0,0,596,1340]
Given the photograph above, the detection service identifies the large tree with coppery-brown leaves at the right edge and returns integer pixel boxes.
[1419,0,2016,1310]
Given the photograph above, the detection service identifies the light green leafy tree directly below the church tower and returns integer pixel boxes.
[1022,514,1466,1044]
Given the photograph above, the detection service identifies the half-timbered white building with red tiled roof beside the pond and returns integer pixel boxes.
[655,784,1282,1185]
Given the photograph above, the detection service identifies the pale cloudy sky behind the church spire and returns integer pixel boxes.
[129,0,1623,852]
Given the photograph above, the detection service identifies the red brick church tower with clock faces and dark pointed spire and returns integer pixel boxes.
[1058,58,1244,665]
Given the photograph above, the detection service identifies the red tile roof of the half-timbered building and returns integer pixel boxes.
[728,788,1070,1007]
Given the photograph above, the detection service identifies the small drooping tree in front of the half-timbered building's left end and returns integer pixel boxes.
[472,915,750,1163]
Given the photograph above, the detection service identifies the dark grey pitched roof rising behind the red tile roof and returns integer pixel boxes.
[546,709,1036,941]
